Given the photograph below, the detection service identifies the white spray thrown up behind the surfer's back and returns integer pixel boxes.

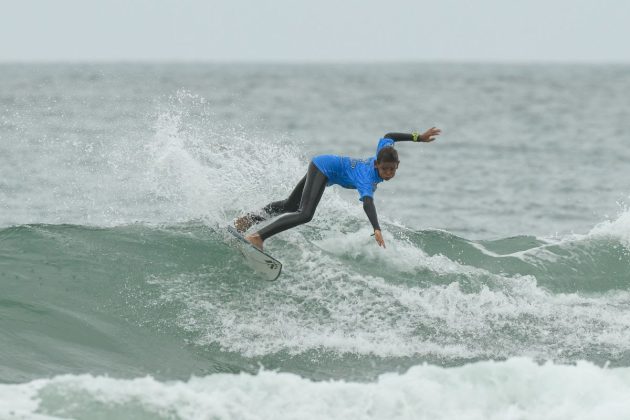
[144,91,306,224]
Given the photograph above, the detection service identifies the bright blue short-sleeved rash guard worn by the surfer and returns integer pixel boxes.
[313,138,394,201]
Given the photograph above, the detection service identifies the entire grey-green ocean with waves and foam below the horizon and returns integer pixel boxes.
[0,63,630,420]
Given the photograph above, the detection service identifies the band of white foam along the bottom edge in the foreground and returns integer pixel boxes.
[0,358,630,420]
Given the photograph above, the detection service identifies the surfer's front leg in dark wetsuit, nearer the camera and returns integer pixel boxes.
[258,162,328,241]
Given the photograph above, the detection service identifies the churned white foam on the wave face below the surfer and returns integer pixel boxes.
[152,226,630,360]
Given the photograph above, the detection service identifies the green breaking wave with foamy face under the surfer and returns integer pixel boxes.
[0,220,630,382]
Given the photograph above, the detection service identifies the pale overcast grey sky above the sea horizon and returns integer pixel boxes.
[0,0,630,62]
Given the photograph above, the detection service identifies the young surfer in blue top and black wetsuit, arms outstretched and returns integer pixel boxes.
[234,127,441,250]
